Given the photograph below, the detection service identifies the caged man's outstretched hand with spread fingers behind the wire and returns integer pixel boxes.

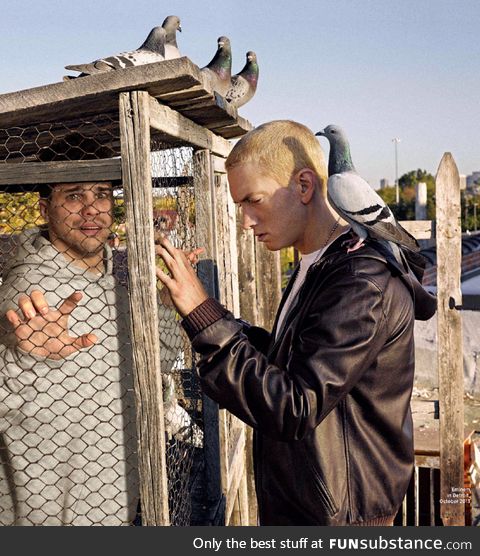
[5,290,97,359]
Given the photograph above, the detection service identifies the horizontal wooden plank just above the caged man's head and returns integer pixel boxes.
[0,158,122,186]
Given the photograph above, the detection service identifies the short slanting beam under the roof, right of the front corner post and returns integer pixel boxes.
[150,98,232,156]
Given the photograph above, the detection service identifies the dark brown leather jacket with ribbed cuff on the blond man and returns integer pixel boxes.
[185,237,435,525]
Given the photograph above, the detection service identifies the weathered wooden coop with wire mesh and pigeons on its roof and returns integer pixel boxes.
[0,58,281,525]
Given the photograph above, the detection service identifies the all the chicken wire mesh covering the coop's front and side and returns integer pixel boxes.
[0,115,203,525]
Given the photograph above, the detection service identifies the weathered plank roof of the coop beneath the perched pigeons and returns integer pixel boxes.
[0,57,251,137]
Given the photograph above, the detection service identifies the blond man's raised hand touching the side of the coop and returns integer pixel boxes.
[155,237,208,317]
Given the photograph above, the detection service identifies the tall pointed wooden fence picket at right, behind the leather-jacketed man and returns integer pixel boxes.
[435,153,465,525]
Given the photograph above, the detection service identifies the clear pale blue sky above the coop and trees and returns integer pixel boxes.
[0,0,480,187]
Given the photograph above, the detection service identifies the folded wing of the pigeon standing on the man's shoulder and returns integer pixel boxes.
[328,172,419,251]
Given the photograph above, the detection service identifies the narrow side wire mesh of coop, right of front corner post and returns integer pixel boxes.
[151,137,203,525]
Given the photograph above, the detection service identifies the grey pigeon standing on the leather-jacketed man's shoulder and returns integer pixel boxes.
[316,125,420,256]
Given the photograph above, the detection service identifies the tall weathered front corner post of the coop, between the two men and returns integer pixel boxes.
[120,91,169,525]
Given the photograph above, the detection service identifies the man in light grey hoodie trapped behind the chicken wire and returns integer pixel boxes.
[0,137,183,525]
